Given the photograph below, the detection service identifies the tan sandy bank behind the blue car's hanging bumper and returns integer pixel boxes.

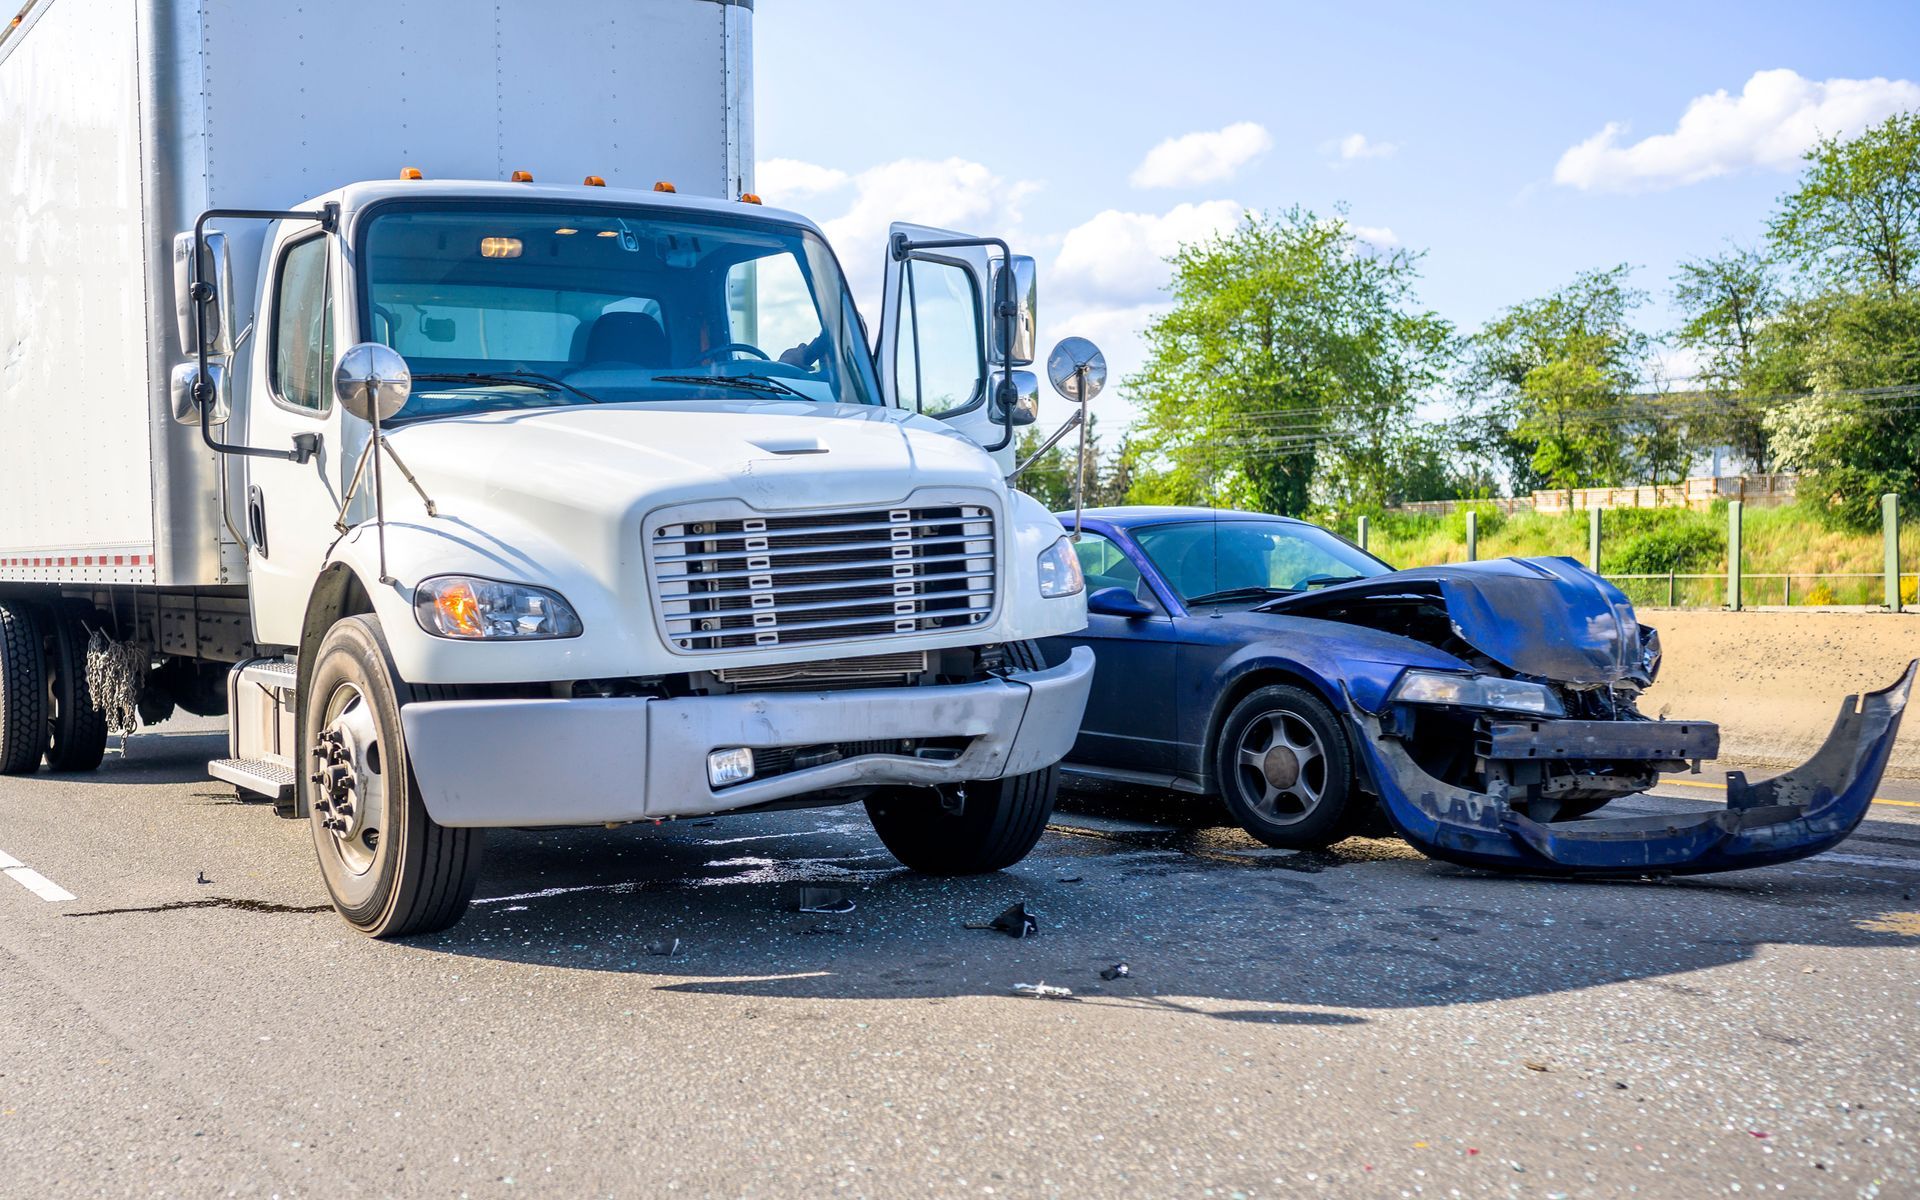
[1640,611,1920,780]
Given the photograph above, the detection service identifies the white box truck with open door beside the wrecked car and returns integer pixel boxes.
[0,0,1092,935]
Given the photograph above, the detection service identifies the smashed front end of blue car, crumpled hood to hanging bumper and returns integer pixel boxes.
[1261,559,1914,876]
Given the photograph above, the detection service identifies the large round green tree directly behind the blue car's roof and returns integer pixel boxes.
[1123,207,1452,513]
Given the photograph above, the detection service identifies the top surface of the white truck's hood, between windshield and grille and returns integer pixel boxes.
[388,399,1004,515]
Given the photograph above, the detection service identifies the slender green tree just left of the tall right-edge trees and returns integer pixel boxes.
[1672,246,1784,470]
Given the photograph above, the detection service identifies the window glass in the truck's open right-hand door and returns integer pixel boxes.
[893,259,987,417]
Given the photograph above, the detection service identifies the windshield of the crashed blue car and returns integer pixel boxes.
[1133,518,1392,605]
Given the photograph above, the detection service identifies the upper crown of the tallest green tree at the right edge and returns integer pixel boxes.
[1766,111,1920,296]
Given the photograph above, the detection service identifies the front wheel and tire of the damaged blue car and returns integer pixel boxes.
[1213,684,1354,851]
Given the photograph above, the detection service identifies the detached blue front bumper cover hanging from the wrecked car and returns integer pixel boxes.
[1350,660,1920,876]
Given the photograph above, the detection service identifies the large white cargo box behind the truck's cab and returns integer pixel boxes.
[0,0,753,586]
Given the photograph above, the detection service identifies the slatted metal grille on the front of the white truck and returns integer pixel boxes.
[647,503,996,653]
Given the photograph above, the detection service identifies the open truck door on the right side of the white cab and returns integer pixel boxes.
[876,223,1014,470]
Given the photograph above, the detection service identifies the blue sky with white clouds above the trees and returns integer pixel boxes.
[755,0,1920,428]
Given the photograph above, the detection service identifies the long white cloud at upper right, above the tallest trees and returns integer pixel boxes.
[1553,69,1920,192]
